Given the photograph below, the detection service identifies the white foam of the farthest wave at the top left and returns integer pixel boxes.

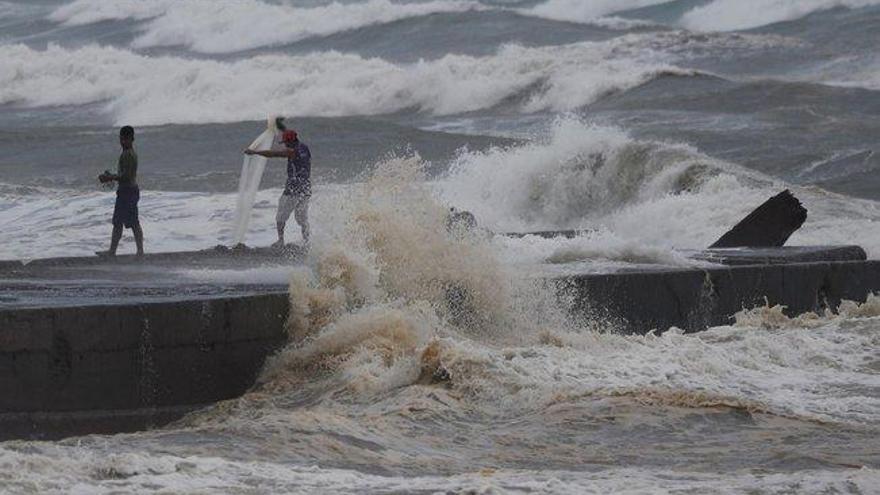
[49,0,480,53]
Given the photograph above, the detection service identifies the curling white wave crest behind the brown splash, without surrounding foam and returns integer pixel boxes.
[443,118,720,229]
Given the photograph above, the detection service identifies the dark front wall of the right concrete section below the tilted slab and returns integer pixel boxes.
[555,261,880,334]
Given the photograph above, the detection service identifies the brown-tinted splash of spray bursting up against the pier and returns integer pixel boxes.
[255,156,578,397]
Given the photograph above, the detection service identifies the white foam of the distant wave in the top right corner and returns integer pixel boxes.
[681,0,880,31]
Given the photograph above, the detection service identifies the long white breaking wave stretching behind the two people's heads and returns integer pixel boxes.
[0,40,690,125]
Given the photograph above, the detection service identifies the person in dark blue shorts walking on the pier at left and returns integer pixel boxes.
[98,125,144,256]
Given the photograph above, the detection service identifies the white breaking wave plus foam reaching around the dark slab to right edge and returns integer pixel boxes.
[438,119,880,264]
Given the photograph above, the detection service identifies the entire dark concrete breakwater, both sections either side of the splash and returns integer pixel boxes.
[0,247,880,439]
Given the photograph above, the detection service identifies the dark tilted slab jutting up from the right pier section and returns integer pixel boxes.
[709,189,807,248]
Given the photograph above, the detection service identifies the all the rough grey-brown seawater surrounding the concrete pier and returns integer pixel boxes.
[0,0,880,494]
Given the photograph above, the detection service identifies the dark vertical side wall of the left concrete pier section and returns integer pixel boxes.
[0,294,288,413]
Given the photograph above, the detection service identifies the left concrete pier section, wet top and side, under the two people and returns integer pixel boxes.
[0,249,298,440]
